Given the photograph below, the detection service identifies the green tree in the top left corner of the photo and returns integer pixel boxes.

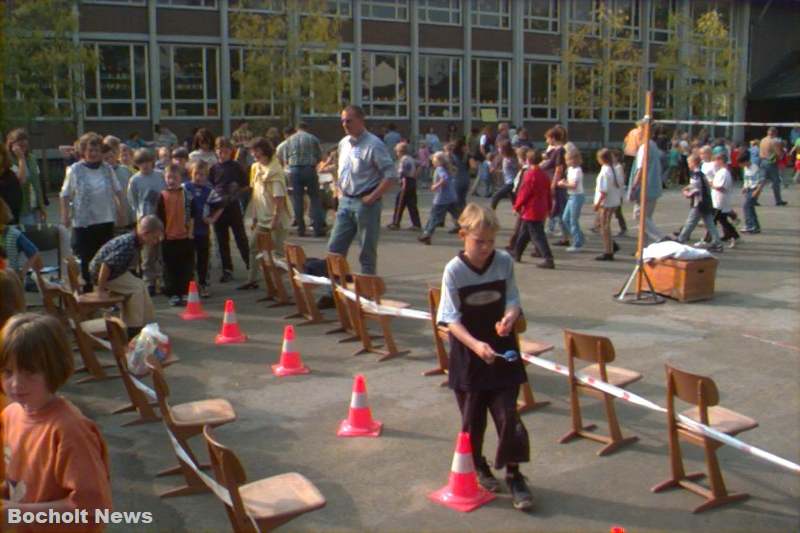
[0,0,97,133]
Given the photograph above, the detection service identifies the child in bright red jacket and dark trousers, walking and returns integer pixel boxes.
[514,150,555,269]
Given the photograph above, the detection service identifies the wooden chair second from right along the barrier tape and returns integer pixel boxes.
[559,329,642,455]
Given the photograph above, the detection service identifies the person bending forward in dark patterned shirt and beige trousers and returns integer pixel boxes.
[89,215,164,336]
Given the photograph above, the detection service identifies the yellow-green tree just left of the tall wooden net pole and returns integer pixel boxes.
[558,2,642,144]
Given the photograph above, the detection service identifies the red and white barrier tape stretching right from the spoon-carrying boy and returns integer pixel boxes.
[522,353,800,474]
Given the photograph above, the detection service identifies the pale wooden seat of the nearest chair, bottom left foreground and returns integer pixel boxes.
[239,472,325,521]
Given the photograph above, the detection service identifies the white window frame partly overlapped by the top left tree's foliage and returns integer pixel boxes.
[81,41,151,121]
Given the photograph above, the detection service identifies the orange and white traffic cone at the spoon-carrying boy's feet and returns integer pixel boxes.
[428,432,495,513]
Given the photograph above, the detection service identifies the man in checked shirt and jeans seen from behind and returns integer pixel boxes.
[277,122,325,237]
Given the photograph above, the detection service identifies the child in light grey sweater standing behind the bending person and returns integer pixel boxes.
[128,148,165,296]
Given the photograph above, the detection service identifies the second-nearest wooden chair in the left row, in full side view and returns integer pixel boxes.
[146,357,236,498]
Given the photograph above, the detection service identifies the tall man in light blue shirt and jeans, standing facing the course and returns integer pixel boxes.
[328,105,397,274]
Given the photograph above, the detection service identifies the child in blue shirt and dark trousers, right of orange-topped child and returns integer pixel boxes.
[183,159,211,298]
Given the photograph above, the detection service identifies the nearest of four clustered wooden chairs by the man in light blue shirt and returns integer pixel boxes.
[352,274,410,361]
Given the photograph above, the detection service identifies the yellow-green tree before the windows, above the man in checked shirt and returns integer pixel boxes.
[231,0,349,123]
